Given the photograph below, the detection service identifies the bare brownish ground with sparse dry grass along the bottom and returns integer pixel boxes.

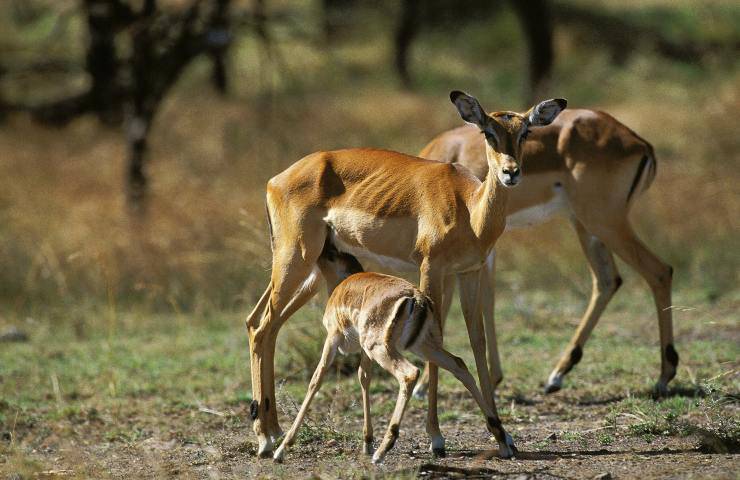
[0,385,740,479]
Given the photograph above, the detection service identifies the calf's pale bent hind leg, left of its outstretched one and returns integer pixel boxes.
[367,345,419,463]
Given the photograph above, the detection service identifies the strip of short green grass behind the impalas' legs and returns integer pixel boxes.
[0,284,740,462]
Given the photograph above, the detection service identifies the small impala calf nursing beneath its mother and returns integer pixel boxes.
[273,246,514,463]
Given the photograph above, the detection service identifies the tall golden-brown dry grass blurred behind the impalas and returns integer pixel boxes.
[0,52,740,313]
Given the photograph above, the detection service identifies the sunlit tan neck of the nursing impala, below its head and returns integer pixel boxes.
[470,160,509,248]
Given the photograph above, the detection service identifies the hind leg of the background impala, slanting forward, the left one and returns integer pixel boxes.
[545,218,622,393]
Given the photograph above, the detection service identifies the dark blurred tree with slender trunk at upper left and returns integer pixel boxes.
[6,0,234,214]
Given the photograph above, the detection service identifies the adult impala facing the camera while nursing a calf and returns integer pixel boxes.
[247,91,566,456]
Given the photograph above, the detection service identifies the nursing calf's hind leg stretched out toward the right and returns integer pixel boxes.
[414,343,516,458]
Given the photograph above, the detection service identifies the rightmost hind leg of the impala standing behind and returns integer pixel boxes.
[603,220,678,395]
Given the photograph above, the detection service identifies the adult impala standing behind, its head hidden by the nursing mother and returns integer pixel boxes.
[416,109,678,395]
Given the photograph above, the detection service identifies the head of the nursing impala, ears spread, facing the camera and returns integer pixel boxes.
[450,90,568,187]
